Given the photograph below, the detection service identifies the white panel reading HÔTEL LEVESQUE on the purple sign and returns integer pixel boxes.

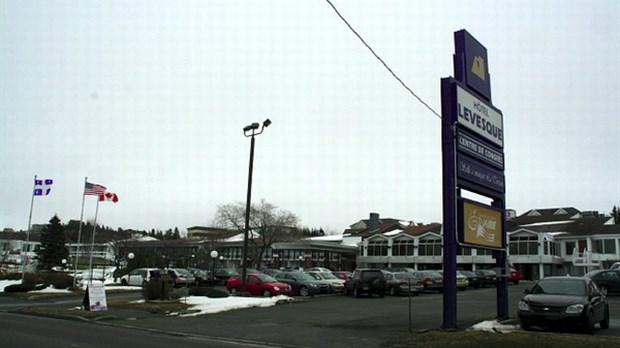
[456,86,504,148]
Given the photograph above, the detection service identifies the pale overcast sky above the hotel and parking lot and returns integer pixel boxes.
[0,0,620,232]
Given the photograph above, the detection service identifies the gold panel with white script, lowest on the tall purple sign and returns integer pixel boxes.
[458,199,504,249]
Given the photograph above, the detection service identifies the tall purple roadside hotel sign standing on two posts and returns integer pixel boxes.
[441,30,508,328]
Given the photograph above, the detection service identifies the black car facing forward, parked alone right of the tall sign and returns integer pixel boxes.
[517,277,609,334]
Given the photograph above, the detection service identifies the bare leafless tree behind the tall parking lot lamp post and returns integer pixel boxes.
[214,199,301,268]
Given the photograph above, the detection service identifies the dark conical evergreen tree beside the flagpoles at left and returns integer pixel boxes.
[36,215,69,270]
